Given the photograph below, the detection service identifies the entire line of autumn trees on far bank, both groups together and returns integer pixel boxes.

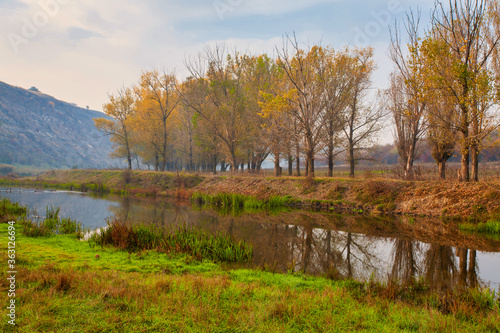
[95,0,500,181]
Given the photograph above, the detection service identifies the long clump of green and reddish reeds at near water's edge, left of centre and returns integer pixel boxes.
[90,219,253,262]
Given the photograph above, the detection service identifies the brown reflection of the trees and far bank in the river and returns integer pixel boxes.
[105,199,496,291]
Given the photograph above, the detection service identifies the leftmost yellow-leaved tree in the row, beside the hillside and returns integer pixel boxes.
[94,88,135,170]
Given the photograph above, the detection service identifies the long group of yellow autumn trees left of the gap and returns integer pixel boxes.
[95,40,382,177]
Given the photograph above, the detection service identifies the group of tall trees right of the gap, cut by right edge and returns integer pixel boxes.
[386,0,500,181]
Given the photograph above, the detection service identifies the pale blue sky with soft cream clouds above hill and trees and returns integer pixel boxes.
[0,0,434,111]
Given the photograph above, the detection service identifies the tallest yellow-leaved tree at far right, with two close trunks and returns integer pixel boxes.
[425,0,500,181]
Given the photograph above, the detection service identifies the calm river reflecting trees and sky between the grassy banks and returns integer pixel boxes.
[0,189,500,291]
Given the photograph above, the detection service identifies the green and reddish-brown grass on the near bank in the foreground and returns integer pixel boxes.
[0,224,500,332]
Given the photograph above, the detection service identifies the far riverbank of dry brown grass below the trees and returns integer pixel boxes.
[0,170,500,222]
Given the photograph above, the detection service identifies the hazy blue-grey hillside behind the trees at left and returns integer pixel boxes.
[0,81,113,168]
